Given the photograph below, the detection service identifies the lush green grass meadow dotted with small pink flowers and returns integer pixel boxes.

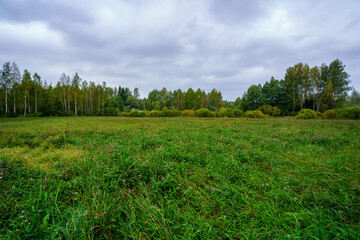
[0,117,360,240]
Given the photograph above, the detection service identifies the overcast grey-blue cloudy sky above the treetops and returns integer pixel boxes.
[0,0,360,101]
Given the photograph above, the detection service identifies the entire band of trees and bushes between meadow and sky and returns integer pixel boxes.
[0,59,360,119]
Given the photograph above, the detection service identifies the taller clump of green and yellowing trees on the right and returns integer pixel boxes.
[238,59,359,113]
